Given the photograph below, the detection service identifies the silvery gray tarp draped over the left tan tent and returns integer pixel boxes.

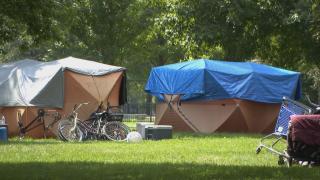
[0,57,124,108]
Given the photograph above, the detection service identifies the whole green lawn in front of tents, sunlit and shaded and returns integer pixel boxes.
[0,133,320,179]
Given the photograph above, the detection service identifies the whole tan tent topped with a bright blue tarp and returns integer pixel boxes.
[145,59,301,133]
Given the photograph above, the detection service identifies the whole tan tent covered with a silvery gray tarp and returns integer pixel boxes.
[0,57,126,137]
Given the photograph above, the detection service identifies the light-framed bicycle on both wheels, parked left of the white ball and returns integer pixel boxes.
[58,103,130,141]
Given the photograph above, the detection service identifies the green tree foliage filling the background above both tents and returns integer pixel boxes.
[0,0,320,99]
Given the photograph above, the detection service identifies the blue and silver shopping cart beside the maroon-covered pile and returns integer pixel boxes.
[256,97,312,163]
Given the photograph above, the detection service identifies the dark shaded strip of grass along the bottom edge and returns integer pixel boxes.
[0,162,320,179]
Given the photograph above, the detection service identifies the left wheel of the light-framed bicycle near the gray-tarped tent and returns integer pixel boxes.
[58,119,83,142]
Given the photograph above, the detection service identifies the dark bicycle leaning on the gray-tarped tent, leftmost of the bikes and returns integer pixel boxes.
[17,109,61,139]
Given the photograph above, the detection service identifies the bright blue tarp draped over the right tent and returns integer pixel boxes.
[145,59,301,103]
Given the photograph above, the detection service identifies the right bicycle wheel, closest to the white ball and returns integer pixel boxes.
[103,121,130,141]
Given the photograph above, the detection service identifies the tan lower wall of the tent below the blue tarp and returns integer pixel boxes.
[156,95,280,133]
